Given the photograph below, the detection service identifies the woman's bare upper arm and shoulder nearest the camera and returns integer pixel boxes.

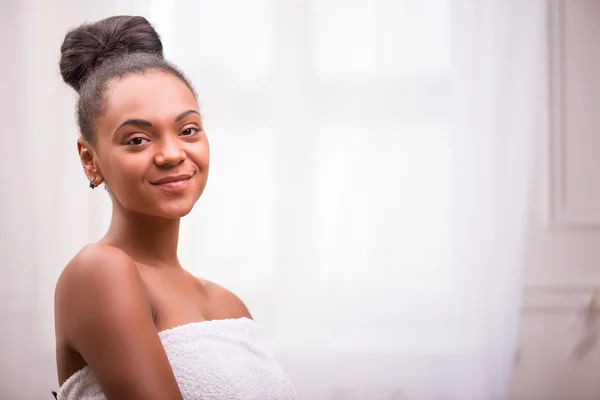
[55,245,182,400]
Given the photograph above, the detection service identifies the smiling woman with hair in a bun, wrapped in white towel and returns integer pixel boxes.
[55,16,296,400]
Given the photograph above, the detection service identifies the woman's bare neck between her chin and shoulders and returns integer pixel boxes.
[101,202,181,267]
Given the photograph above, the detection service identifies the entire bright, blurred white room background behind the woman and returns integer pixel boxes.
[0,0,600,400]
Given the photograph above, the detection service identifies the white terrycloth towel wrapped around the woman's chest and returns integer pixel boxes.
[58,318,297,400]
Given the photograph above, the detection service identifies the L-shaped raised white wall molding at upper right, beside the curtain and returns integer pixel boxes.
[548,0,600,229]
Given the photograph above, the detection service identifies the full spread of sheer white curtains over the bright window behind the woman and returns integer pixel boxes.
[2,0,545,400]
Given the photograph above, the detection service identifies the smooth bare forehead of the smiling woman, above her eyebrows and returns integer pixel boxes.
[103,72,198,124]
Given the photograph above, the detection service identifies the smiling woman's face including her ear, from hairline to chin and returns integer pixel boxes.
[79,72,209,219]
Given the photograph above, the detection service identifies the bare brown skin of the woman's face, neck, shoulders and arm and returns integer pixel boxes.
[55,72,251,400]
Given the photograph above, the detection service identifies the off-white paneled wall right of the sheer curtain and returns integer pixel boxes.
[513,0,600,400]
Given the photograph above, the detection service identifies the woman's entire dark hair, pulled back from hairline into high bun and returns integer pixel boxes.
[60,16,196,144]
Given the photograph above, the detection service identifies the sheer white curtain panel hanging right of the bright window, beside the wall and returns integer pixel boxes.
[452,0,546,399]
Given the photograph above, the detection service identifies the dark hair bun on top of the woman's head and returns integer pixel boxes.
[60,16,163,92]
